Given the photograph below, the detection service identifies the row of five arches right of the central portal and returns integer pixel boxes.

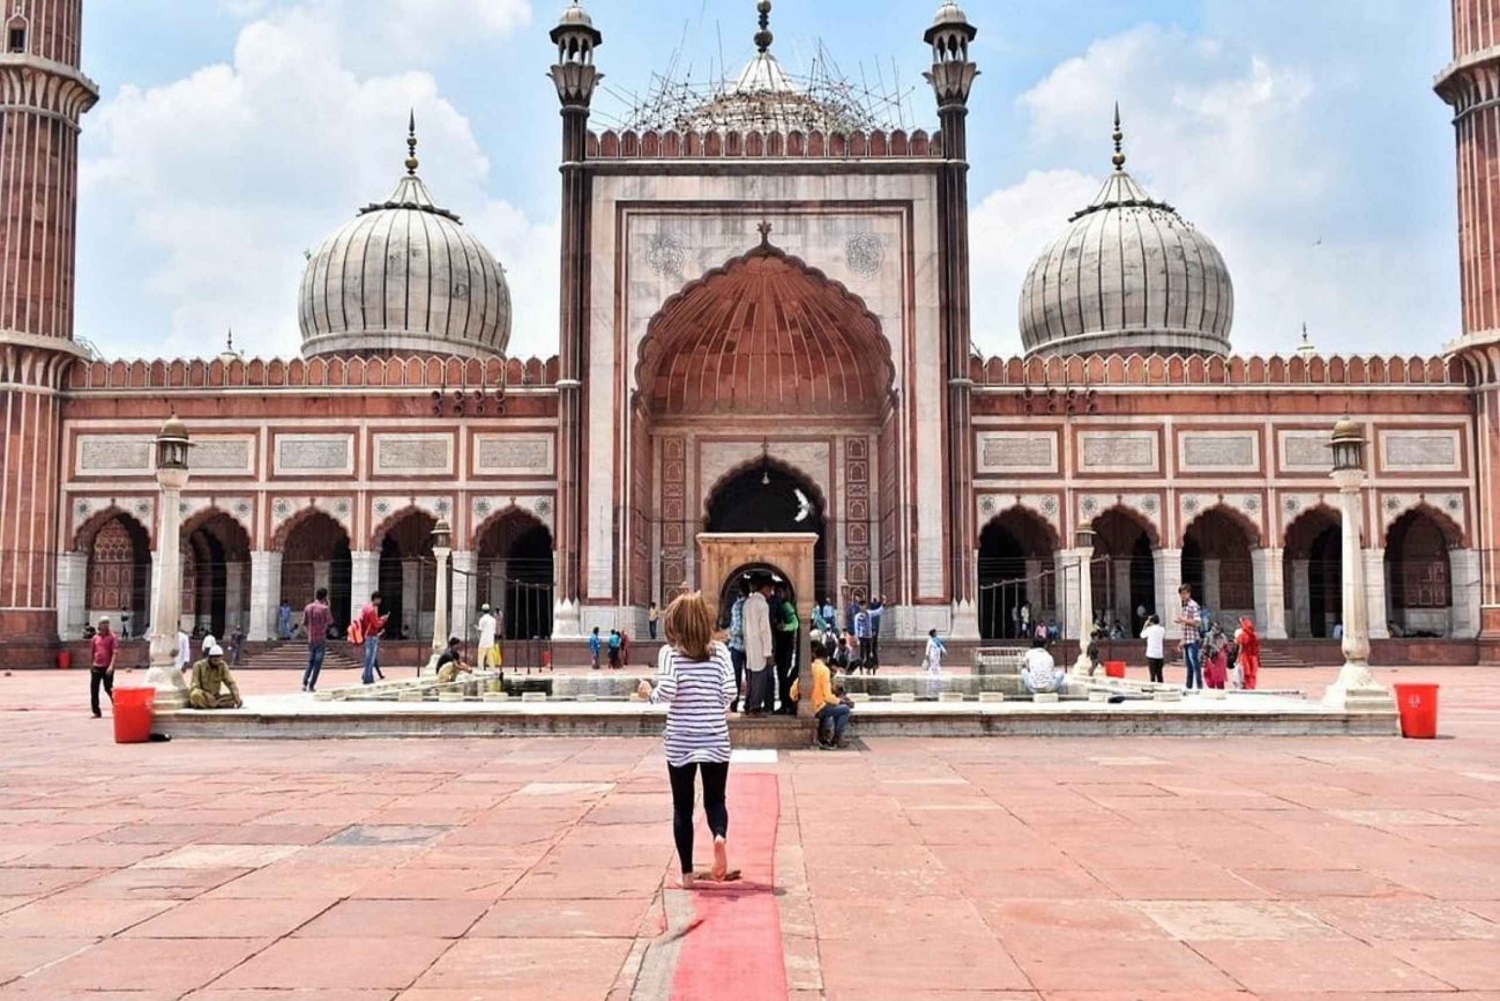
[978,504,1482,639]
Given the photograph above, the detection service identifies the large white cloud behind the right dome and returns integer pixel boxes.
[974,26,1457,360]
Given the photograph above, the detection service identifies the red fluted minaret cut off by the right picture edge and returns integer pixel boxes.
[1437,0,1500,642]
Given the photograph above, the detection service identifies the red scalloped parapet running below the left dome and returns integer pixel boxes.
[68,356,558,393]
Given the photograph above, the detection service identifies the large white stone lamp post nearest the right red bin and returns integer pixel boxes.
[1323,417,1395,711]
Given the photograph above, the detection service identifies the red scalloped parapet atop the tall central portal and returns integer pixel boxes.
[588,129,942,161]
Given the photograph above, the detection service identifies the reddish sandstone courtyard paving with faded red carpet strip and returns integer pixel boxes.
[0,668,1500,1001]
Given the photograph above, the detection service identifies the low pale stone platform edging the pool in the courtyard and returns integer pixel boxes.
[156,692,1398,749]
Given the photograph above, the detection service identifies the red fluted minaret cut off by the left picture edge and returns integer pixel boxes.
[0,0,99,645]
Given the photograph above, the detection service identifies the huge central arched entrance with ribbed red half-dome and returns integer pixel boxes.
[626,238,900,621]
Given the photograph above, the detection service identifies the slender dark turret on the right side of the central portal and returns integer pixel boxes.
[923,0,980,639]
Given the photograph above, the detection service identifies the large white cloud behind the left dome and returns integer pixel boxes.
[81,0,557,356]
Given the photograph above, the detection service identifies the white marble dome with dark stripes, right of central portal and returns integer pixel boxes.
[1020,132,1235,354]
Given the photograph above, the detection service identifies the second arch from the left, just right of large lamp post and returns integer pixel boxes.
[182,510,251,636]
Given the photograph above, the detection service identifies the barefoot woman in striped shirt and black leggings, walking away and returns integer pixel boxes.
[641,594,740,885]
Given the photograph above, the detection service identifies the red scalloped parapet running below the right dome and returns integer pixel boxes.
[969,354,1472,390]
